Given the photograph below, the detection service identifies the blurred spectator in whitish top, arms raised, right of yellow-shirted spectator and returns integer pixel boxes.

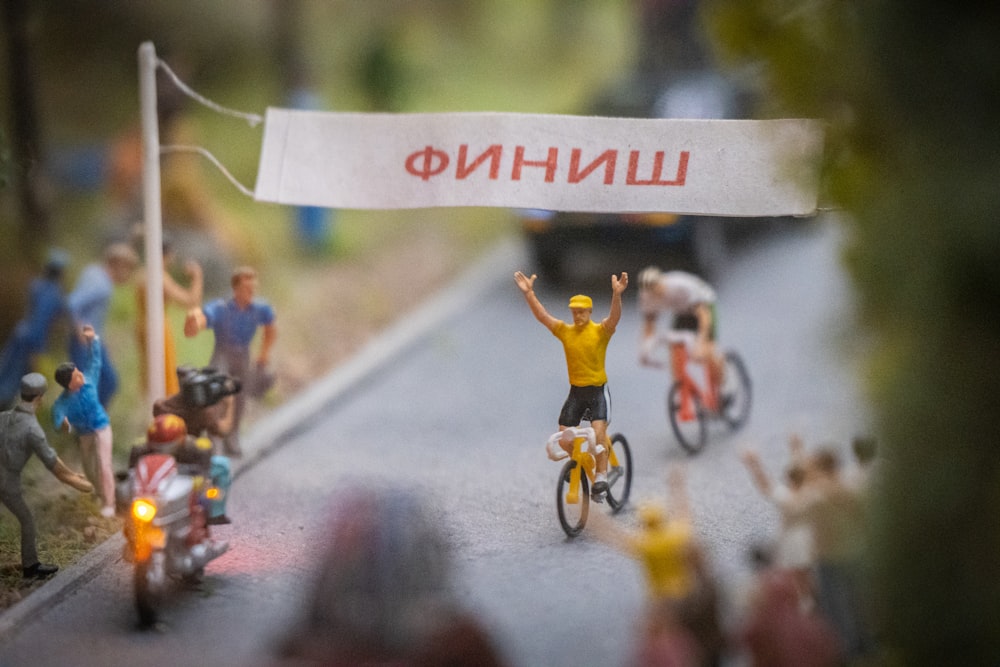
[743,436,815,607]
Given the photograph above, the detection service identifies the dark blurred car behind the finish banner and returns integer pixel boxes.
[519,69,792,282]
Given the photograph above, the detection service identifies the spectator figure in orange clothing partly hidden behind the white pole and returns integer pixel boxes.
[135,239,204,396]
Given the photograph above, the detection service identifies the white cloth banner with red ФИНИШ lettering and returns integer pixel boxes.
[255,108,823,216]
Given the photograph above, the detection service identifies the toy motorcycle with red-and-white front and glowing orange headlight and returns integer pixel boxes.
[118,453,229,625]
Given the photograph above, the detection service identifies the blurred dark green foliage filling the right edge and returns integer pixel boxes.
[707,0,1000,665]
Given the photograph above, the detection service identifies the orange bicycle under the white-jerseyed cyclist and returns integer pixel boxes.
[664,331,752,454]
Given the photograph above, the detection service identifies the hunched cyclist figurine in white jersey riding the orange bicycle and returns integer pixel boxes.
[639,266,725,396]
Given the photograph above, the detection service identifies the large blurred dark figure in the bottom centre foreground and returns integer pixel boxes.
[278,488,503,667]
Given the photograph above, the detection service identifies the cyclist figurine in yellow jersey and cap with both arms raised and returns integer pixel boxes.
[514,271,628,502]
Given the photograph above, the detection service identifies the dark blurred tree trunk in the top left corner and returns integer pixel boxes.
[3,0,51,257]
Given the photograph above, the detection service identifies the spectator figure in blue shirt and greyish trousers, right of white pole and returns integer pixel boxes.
[184,267,278,456]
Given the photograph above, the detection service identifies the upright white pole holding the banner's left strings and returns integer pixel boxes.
[139,42,167,408]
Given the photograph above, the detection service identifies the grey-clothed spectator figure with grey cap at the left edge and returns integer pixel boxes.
[0,373,94,579]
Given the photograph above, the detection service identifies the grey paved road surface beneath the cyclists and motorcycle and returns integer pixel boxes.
[0,219,865,667]
